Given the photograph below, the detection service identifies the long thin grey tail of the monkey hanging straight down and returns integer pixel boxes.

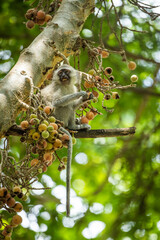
[60,127,72,217]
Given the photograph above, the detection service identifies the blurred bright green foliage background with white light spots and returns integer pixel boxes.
[0,0,160,240]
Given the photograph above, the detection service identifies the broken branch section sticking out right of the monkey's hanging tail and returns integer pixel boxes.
[74,127,136,138]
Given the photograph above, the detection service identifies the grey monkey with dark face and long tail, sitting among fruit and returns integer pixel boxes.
[41,64,93,216]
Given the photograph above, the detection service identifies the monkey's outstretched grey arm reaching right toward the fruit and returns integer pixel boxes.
[52,91,88,107]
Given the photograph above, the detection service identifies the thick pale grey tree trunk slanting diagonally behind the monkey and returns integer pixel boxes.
[0,0,94,137]
